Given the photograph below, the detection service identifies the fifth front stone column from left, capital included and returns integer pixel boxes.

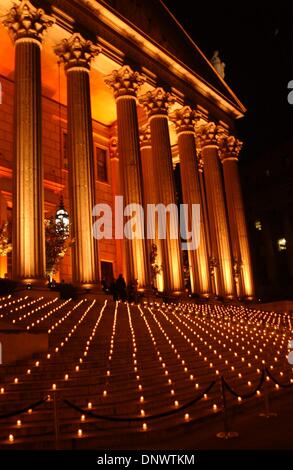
[171,106,211,297]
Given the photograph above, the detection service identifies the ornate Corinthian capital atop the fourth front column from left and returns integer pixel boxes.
[139,88,175,117]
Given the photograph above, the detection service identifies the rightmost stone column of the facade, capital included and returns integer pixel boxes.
[220,136,254,299]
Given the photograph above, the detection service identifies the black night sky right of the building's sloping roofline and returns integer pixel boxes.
[165,0,293,158]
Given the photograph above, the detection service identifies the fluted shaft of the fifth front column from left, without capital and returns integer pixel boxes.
[177,129,210,296]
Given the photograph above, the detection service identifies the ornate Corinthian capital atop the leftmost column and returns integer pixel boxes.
[3,0,55,43]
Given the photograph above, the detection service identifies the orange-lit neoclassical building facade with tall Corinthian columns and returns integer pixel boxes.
[0,0,254,298]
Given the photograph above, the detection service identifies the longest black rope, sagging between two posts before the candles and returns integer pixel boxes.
[63,380,216,422]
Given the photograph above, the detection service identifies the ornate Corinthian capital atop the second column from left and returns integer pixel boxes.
[55,33,101,70]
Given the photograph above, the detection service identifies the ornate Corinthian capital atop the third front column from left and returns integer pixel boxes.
[105,65,145,98]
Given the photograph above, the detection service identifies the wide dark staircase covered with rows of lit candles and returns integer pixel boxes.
[0,296,293,450]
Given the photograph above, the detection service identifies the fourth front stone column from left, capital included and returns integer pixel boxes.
[140,88,184,292]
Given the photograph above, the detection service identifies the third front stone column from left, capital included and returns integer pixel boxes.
[105,65,147,286]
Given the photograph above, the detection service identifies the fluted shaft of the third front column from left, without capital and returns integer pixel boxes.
[117,96,147,286]
